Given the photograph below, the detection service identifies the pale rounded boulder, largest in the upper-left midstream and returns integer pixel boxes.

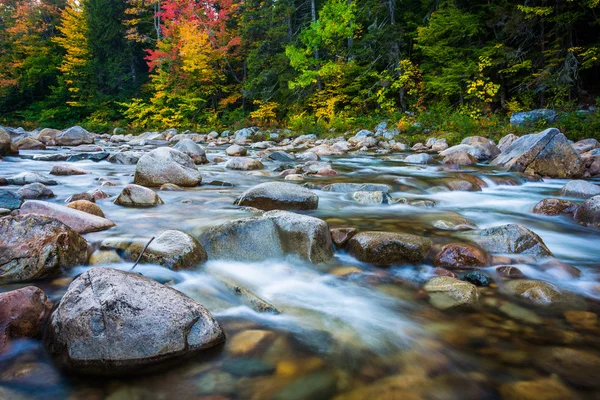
[133,147,202,187]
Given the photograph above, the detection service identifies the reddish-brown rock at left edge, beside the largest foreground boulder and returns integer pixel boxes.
[0,286,52,353]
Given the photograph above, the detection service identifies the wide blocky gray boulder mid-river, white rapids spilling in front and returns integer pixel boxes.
[200,211,333,263]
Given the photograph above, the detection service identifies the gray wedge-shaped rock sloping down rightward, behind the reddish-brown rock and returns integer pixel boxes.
[461,224,552,257]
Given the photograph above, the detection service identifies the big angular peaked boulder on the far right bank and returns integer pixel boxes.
[491,128,584,178]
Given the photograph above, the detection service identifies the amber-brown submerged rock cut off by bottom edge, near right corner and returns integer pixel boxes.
[500,377,579,400]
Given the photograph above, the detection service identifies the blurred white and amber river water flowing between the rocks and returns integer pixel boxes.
[0,148,600,400]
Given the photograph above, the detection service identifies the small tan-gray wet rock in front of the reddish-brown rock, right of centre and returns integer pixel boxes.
[423,276,479,310]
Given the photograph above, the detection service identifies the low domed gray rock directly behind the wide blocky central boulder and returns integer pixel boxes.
[234,182,319,210]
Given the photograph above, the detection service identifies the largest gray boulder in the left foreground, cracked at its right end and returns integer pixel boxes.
[46,267,225,375]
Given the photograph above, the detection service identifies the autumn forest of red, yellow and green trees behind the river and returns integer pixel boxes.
[0,0,600,138]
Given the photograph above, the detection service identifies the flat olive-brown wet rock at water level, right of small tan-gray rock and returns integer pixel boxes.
[501,279,585,309]
